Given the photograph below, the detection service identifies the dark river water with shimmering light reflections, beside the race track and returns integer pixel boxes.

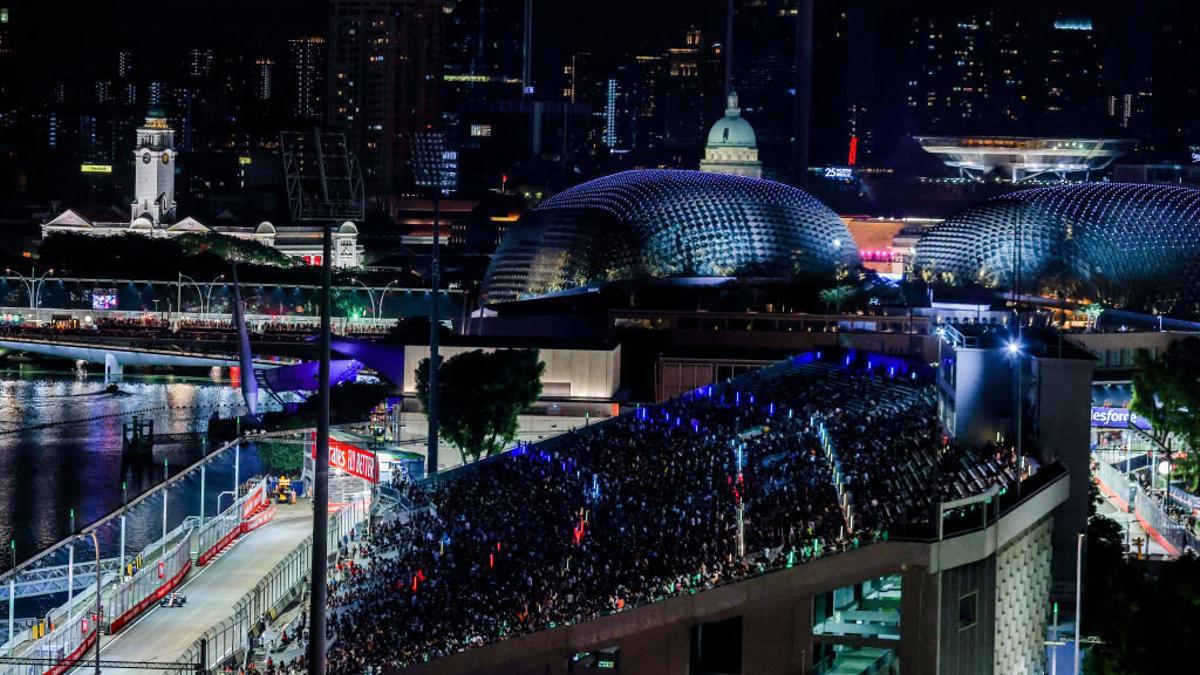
[0,371,241,569]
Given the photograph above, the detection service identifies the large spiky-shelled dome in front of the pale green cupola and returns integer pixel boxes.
[484,169,859,303]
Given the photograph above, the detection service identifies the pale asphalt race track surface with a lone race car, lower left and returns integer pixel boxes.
[74,502,312,675]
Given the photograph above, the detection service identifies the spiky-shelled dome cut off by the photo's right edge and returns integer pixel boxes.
[914,183,1200,313]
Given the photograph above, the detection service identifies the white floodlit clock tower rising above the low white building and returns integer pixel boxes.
[131,108,175,226]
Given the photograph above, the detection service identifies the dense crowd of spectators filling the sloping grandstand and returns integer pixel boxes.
[319,364,1000,674]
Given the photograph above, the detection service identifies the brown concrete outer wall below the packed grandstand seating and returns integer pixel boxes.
[404,542,937,675]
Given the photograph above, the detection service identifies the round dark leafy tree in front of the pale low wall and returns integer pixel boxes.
[416,350,546,462]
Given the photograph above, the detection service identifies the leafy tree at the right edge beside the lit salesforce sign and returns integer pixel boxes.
[1130,338,1200,492]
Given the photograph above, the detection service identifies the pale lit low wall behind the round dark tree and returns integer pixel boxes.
[404,344,620,400]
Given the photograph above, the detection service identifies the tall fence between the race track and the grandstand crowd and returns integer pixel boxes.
[178,496,371,670]
